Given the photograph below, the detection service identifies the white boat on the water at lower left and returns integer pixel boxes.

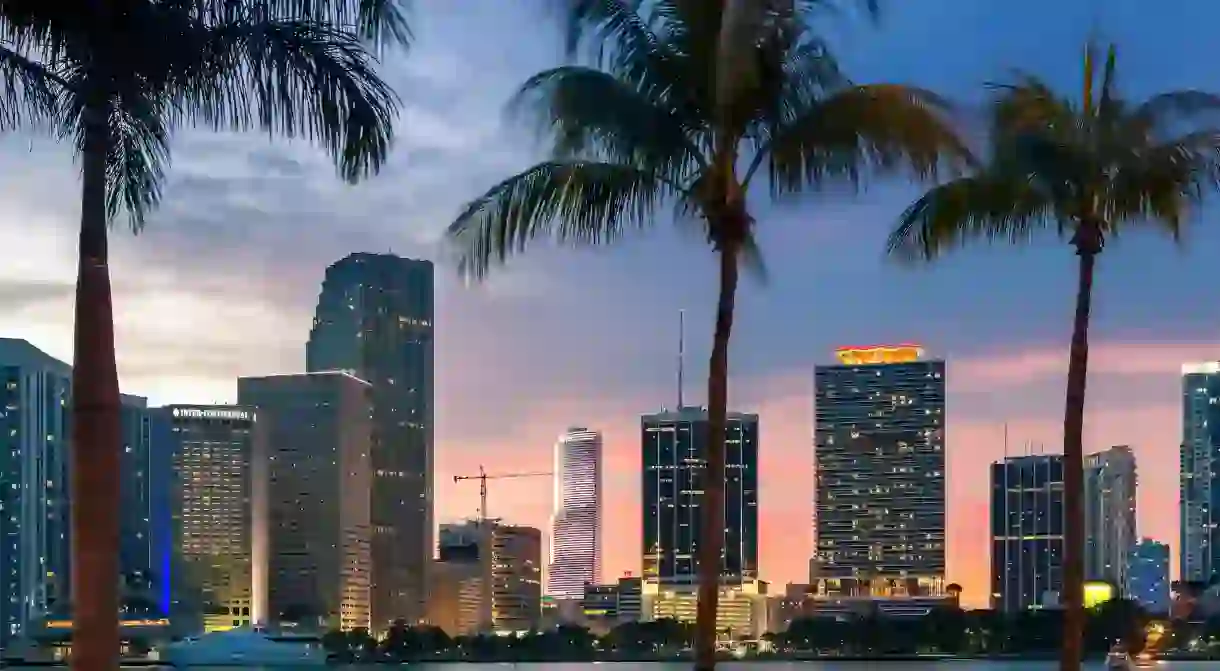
[159,628,326,669]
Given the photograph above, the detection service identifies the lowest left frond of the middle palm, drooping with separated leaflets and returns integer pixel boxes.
[448,161,672,278]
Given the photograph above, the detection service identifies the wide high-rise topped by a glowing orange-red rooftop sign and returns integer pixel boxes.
[810,345,946,597]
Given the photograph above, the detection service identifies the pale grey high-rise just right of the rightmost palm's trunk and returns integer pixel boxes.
[1085,445,1138,589]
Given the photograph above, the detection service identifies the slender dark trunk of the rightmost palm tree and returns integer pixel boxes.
[1059,233,1102,671]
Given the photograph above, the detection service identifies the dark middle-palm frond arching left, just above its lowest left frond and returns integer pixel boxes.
[510,66,704,175]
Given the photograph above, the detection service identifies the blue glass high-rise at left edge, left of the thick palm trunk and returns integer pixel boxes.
[0,338,72,647]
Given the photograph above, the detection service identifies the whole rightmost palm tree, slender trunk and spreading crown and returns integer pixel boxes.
[889,43,1220,671]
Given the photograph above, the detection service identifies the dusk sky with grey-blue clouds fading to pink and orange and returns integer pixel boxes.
[0,0,1220,604]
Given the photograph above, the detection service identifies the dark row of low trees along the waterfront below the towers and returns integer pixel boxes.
[323,599,1220,662]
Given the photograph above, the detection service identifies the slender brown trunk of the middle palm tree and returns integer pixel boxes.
[694,243,738,671]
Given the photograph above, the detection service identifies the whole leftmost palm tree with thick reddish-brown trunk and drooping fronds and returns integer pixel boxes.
[0,0,407,670]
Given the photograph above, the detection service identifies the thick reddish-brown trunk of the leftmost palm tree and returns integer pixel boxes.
[71,100,122,671]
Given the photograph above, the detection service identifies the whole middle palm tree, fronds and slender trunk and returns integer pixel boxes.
[449,0,967,669]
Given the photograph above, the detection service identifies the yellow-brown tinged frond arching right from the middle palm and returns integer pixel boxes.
[761,84,974,196]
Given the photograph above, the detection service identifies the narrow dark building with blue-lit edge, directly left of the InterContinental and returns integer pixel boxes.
[118,394,159,600]
